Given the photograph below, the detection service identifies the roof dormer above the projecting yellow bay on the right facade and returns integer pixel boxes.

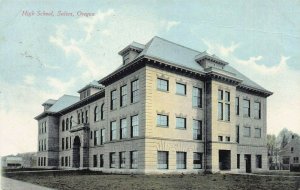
[195,51,228,69]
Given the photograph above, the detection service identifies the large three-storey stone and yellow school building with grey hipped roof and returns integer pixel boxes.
[35,37,272,173]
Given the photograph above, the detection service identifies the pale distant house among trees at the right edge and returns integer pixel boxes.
[279,135,300,171]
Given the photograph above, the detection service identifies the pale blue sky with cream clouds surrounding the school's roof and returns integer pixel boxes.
[0,0,300,156]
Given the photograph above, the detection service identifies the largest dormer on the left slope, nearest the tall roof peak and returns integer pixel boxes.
[119,42,145,65]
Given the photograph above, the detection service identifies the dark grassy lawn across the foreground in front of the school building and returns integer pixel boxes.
[2,171,300,190]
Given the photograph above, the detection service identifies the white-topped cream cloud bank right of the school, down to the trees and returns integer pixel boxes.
[204,40,300,134]
